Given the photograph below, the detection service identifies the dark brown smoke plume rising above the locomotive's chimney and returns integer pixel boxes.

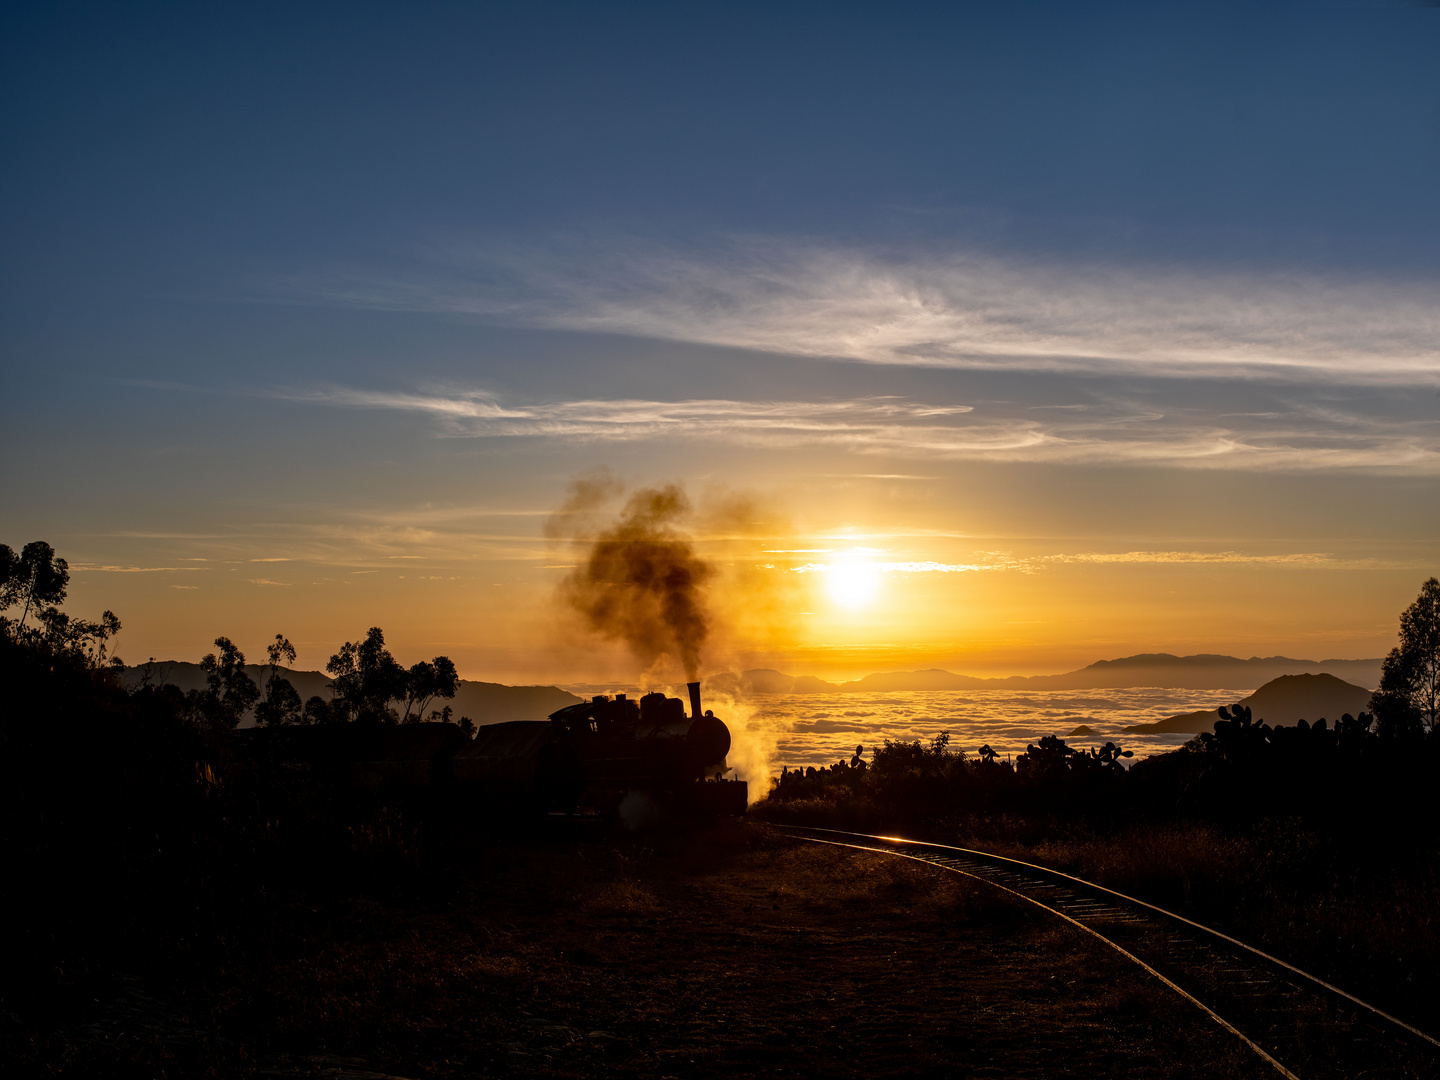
[546,474,714,680]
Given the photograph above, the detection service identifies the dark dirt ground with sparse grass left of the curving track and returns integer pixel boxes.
[16,822,1273,1080]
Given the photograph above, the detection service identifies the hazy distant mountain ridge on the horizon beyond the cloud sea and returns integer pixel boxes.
[740,652,1380,694]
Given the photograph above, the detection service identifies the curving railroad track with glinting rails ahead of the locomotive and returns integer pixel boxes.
[775,825,1440,1080]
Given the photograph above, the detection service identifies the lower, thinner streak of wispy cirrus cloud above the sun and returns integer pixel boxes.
[275,387,1440,474]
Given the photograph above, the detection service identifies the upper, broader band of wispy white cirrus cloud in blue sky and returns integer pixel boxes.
[268,238,1440,384]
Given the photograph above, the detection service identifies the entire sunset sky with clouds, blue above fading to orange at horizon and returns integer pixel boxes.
[0,3,1440,677]
